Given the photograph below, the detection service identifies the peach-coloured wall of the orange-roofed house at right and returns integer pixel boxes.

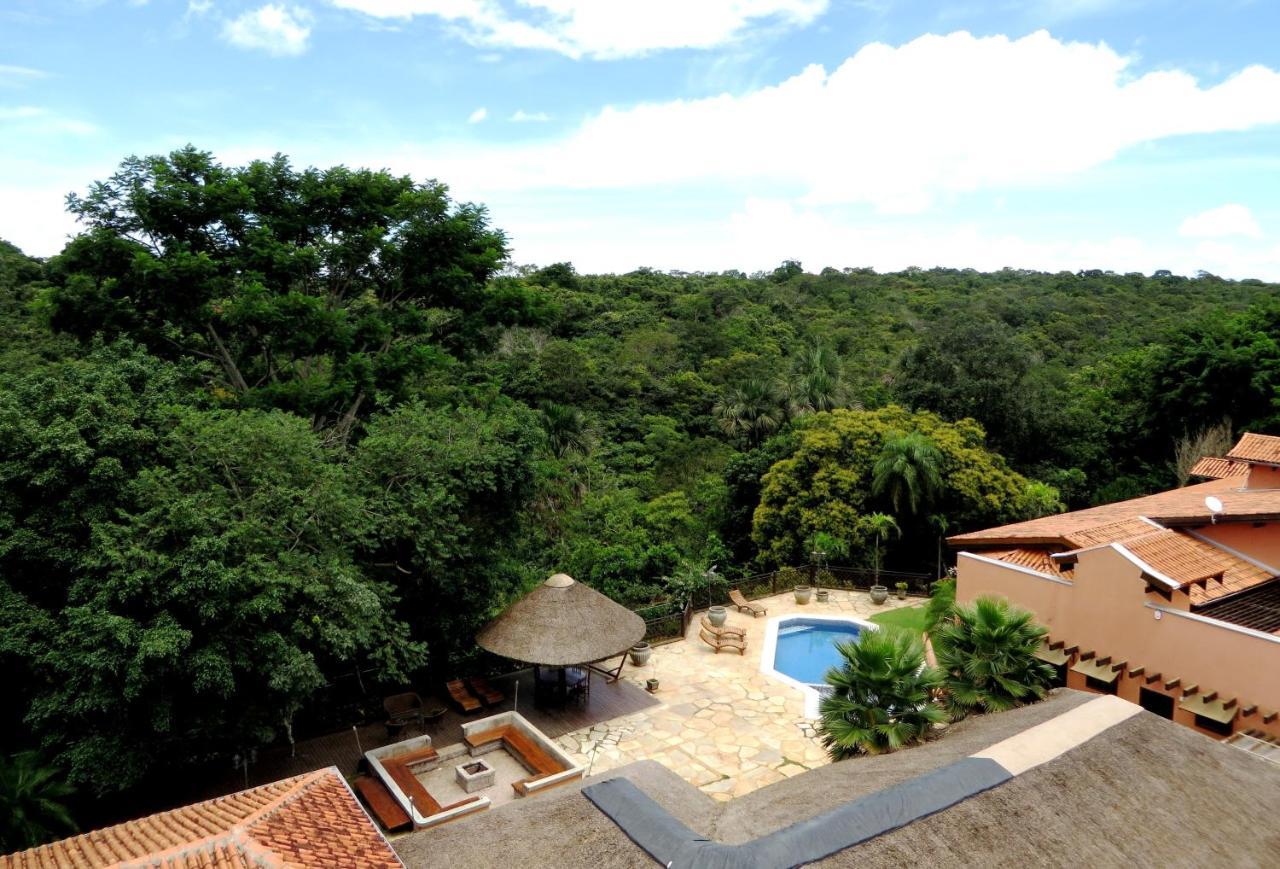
[956,546,1280,735]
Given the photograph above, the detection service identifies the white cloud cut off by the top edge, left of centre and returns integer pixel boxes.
[330,0,829,59]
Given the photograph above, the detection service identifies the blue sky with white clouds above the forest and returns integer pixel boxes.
[0,0,1280,279]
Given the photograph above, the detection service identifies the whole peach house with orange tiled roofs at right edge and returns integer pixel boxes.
[950,434,1280,738]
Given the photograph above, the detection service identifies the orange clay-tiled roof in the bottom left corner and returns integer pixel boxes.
[0,767,404,869]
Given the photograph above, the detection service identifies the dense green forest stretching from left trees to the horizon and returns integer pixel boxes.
[0,148,1280,829]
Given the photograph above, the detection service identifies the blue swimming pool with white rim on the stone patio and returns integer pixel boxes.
[760,616,876,718]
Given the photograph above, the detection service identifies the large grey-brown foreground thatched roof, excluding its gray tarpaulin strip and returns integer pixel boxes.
[394,690,1280,869]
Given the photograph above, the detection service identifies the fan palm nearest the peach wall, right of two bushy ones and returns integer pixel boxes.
[932,596,1055,719]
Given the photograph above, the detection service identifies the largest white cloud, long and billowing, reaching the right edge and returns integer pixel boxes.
[409,32,1280,212]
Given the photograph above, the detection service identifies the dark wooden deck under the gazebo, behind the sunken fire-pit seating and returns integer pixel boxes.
[198,669,658,799]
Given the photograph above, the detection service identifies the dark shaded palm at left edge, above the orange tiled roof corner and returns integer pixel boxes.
[0,751,76,854]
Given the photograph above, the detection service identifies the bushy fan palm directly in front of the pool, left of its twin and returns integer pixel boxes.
[818,628,946,760]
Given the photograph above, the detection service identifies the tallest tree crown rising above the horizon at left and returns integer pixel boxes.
[49,146,509,439]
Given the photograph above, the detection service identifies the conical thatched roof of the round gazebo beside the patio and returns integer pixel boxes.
[476,573,645,667]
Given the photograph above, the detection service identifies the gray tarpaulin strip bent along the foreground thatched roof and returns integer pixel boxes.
[582,758,1012,869]
